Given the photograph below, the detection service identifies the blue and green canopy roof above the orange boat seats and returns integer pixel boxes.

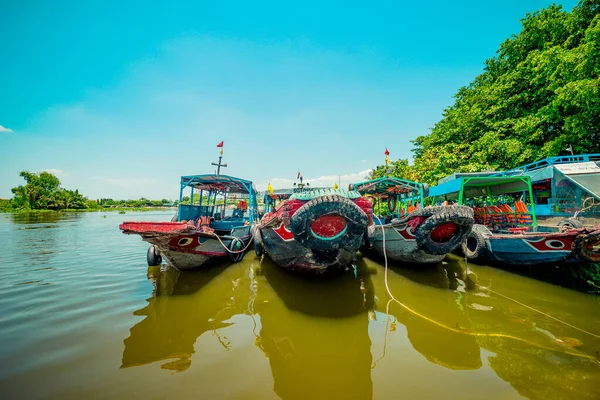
[429,174,531,200]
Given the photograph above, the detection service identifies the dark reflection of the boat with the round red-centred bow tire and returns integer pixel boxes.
[256,261,374,400]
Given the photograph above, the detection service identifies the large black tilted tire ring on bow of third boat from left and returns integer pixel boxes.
[418,206,473,255]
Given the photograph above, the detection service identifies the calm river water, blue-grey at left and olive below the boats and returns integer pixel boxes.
[0,212,600,400]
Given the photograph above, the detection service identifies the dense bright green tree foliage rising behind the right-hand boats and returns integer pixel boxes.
[373,0,600,184]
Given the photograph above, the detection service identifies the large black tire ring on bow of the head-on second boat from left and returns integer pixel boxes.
[290,194,368,250]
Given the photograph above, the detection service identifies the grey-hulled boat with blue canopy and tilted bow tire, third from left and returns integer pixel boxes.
[350,177,473,264]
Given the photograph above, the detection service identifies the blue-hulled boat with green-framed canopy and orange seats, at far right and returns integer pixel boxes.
[429,173,600,265]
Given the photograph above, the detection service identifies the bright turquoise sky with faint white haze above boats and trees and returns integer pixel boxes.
[0,0,576,198]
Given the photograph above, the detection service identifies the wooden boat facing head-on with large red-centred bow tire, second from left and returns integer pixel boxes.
[254,177,372,274]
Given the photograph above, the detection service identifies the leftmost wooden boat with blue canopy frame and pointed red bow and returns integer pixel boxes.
[119,153,258,270]
